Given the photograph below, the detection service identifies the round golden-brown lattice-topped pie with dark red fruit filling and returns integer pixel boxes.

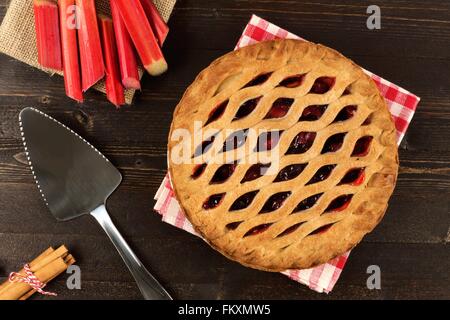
[168,40,398,271]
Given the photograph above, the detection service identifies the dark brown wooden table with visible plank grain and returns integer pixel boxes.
[0,0,450,300]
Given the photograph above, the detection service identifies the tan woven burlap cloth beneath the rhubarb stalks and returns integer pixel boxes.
[0,0,176,104]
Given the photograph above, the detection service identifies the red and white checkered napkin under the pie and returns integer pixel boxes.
[154,15,420,293]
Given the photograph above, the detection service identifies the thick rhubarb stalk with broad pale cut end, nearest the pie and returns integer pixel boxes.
[112,0,167,76]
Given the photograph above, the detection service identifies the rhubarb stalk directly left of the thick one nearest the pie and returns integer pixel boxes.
[110,0,141,90]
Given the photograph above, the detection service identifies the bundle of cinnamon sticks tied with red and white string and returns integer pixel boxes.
[0,245,75,300]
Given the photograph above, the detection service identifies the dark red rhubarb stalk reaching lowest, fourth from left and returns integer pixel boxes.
[99,15,125,107]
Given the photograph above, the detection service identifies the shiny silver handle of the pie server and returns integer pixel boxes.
[91,205,172,300]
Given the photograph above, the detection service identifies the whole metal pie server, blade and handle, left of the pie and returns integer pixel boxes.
[19,108,172,300]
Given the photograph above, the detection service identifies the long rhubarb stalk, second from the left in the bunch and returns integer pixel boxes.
[58,0,83,102]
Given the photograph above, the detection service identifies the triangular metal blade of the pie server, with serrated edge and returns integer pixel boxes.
[20,108,122,221]
